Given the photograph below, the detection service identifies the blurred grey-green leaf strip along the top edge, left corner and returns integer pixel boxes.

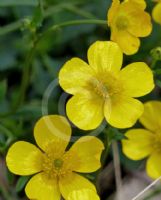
[0,0,38,7]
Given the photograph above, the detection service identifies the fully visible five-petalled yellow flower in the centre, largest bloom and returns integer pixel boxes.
[59,41,154,130]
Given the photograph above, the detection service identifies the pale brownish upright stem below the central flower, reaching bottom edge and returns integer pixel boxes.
[112,140,122,200]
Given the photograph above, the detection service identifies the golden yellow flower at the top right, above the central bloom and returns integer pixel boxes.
[107,0,152,55]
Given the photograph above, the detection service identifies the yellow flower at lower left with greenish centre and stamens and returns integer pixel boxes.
[6,115,104,200]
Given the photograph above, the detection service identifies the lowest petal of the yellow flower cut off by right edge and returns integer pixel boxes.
[146,152,161,179]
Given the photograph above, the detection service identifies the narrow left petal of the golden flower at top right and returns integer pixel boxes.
[107,0,120,26]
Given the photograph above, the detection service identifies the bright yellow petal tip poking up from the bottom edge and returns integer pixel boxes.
[67,189,100,200]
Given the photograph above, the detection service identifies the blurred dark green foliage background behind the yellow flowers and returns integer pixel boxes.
[0,0,161,200]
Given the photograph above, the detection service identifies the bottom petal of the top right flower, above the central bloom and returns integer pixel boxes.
[111,28,140,55]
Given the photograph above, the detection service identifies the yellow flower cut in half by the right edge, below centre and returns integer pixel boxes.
[122,101,161,178]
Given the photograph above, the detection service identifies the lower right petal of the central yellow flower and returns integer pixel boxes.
[104,96,143,128]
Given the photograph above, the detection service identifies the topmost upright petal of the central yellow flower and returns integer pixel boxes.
[88,41,123,72]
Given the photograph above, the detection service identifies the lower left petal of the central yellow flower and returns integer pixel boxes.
[66,92,103,130]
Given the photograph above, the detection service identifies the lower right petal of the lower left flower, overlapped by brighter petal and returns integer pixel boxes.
[59,173,96,199]
